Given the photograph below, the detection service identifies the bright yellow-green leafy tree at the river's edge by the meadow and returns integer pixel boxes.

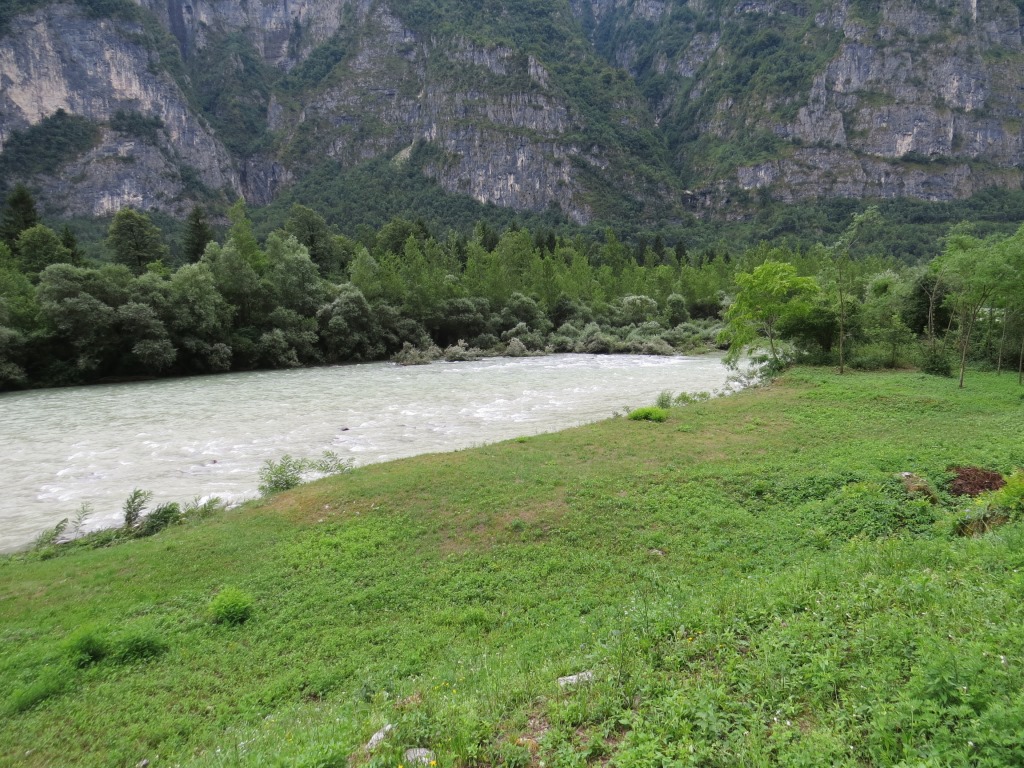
[720,261,818,366]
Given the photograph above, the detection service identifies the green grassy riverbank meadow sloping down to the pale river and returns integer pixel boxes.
[0,369,1024,768]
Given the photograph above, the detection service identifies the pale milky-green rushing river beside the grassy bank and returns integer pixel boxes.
[0,354,729,552]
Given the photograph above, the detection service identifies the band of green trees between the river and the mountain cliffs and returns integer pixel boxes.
[0,185,1024,389]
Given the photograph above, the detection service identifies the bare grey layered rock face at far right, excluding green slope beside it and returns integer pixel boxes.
[738,0,1024,200]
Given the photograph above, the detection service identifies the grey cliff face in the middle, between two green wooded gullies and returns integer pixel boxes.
[291,5,591,222]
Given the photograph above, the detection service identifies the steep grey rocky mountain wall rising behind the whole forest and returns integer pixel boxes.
[0,0,1024,223]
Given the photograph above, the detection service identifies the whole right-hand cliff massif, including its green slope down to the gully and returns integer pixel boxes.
[573,0,1024,205]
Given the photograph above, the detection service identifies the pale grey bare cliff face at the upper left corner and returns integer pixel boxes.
[0,5,241,215]
